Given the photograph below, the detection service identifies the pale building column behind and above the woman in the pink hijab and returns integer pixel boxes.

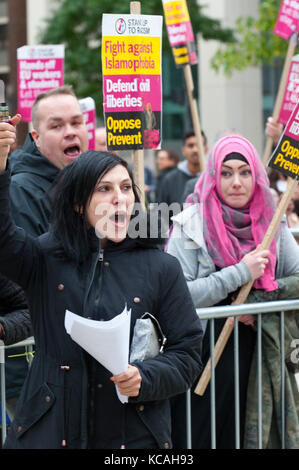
[198,0,264,153]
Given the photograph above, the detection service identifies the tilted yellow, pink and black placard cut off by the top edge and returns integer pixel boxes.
[162,0,197,67]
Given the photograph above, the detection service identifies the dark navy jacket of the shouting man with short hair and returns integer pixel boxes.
[9,134,59,236]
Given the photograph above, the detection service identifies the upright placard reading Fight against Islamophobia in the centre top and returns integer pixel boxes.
[102,14,162,150]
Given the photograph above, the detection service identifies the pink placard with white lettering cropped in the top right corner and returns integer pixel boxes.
[274,0,299,39]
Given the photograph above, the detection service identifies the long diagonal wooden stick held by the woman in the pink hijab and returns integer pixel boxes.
[194,177,298,395]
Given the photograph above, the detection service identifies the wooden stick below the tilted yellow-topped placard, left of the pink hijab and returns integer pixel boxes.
[184,64,205,172]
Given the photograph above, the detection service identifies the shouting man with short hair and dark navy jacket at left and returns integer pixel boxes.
[10,85,88,236]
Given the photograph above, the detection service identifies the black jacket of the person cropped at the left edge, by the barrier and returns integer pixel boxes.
[0,274,32,398]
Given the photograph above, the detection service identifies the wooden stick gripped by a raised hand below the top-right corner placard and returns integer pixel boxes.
[263,33,298,167]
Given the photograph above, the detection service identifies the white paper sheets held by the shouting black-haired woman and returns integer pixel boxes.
[64,306,131,403]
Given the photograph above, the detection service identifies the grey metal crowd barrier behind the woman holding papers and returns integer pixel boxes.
[0,299,299,449]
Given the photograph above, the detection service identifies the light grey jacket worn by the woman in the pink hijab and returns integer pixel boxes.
[167,204,299,308]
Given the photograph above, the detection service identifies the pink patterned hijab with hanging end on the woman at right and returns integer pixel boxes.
[187,136,278,291]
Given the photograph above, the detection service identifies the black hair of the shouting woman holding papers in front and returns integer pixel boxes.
[50,150,140,264]
